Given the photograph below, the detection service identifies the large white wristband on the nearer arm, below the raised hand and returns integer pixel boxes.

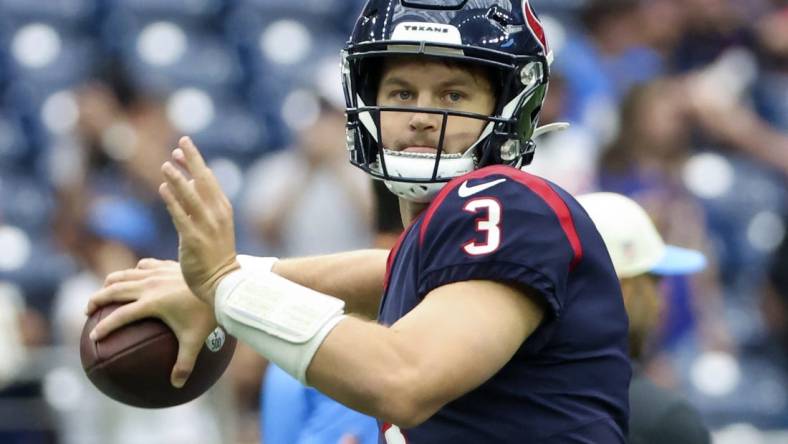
[214,268,345,384]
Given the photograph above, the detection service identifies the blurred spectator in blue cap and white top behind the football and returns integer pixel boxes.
[52,198,227,444]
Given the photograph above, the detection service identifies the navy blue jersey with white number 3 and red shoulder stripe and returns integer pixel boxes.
[379,166,631,444]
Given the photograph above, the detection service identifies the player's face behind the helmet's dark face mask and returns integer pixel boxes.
[377,57,495,154]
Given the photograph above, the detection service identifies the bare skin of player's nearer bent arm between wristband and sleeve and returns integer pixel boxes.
[305,281,545,428]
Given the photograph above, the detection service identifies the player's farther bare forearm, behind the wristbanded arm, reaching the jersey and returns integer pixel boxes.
[272,250,388,319]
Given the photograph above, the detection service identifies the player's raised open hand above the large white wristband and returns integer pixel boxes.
[159,137,240,306]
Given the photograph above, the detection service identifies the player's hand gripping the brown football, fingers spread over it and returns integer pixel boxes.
[87,259,217,387]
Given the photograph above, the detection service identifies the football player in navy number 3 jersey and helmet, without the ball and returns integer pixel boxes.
[88,0,631,444]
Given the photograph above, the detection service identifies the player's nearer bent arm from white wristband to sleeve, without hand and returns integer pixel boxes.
[215,270,544,428]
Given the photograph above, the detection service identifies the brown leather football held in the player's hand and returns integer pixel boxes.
[79,304,236,409]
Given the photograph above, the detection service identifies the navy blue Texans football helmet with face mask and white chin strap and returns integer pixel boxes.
[342,0,551,202]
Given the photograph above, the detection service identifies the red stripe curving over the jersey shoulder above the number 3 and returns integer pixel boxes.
[419,165,583,270]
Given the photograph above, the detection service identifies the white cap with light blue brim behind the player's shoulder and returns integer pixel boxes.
[577,193,706,278]
